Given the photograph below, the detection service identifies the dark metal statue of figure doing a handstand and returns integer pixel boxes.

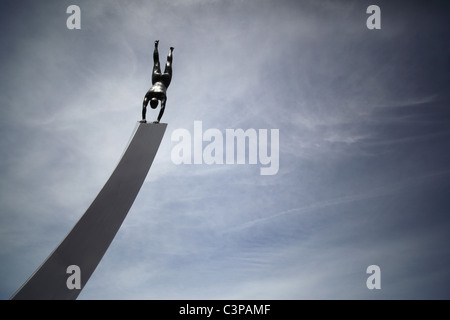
[140,40,173,123]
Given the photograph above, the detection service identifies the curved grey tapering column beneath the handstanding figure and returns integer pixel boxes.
[11,123,167,300]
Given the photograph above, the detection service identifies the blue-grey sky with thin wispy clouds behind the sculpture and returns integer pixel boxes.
[0,0,450,299]
